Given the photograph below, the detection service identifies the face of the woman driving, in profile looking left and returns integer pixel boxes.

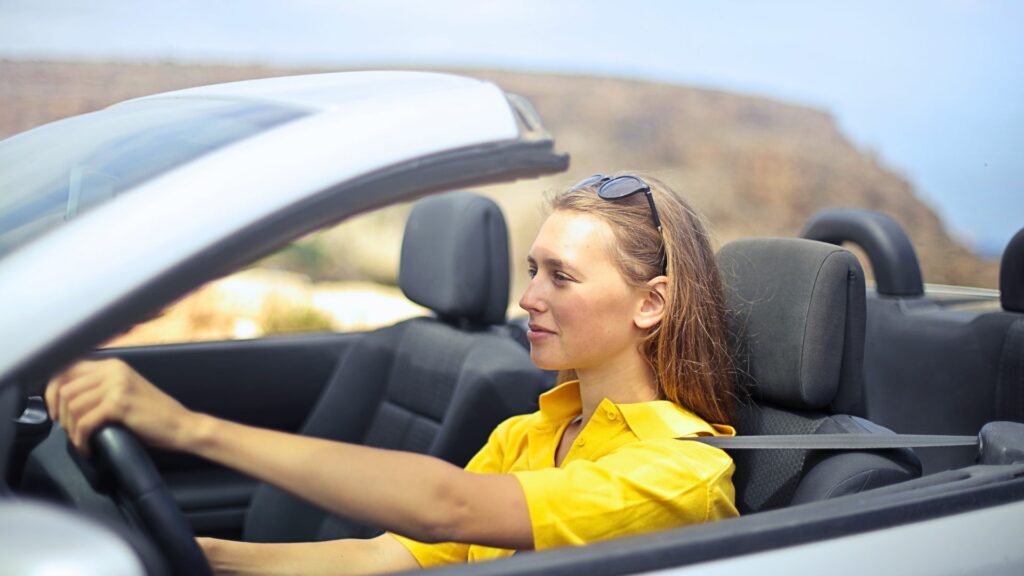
[519,210,644,370]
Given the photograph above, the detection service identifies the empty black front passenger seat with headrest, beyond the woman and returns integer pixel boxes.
[244,193,550,541]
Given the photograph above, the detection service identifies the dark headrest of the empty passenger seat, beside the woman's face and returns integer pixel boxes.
[398,192,509,325]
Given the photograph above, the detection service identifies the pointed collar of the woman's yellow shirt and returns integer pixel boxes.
[540,380,736,440]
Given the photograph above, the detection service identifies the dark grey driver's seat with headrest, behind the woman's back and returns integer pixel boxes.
[718,239,921,512]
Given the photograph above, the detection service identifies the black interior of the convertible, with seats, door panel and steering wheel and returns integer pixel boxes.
[5,192,1024,573]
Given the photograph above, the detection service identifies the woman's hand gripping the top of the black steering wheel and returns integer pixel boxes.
[46,359,196,454]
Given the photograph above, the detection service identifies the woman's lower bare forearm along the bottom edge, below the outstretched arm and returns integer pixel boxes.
[197,534,420,576]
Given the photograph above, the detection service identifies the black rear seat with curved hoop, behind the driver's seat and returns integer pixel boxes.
[801,208,1024,474]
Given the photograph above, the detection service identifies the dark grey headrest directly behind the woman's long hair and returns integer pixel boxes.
[718,238,865,415]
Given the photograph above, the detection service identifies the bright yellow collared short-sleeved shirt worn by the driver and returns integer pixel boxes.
[394,380,738,568]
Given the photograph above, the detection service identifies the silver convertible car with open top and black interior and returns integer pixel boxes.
[0,72,1024,576]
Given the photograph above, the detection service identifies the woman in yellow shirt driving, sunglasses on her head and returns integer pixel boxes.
[46,175,736,574]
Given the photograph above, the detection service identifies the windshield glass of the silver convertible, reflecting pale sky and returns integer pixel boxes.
[0,98,304,257]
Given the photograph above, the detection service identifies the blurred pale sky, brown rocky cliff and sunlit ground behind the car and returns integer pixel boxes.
[0,0,1024,343]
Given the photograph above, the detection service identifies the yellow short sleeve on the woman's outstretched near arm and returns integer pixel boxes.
[512,439,737,550]
